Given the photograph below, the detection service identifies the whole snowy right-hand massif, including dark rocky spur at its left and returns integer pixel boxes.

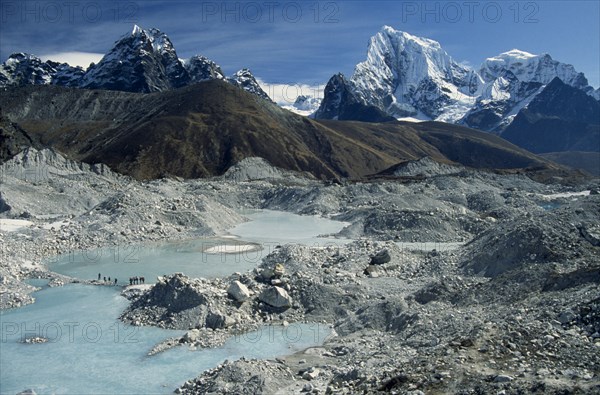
[316,26,600,132]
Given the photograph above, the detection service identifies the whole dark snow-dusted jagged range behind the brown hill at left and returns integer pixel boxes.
[0,25,280,101]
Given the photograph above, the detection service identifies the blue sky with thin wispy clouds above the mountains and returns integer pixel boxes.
[0,0,600,87]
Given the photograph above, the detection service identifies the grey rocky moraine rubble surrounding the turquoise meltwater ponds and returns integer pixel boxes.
[0,150,600,394]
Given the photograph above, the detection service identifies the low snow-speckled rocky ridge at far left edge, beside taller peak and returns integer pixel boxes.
[0,52,84,86]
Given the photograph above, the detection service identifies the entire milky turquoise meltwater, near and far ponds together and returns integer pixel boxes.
[0,211,346,394]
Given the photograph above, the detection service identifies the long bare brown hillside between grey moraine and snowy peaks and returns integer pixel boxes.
[0,80,572,179]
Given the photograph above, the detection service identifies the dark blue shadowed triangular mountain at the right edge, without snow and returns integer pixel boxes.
[502,78,600,153]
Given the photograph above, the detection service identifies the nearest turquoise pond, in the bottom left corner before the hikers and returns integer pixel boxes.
[0,284,329,394]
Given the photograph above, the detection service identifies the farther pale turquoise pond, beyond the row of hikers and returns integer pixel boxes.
[49,210,347,284]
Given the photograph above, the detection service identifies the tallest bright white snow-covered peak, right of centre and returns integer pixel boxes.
[351,26,479,118]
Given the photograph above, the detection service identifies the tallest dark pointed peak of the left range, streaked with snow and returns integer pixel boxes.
[81,25,189,92]
